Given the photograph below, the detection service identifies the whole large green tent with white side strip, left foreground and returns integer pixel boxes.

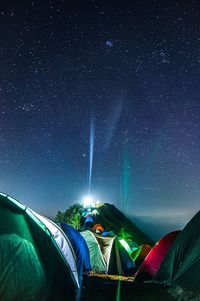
[0,193,79,301]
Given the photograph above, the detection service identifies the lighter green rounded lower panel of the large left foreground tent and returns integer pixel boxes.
[0,233,46,301]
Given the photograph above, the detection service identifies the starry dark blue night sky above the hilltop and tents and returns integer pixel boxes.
[0,0,200,237]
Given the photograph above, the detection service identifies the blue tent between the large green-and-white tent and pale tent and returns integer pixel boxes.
[60,223,92,277]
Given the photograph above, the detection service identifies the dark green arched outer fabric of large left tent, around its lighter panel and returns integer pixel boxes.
[0,193,78,301]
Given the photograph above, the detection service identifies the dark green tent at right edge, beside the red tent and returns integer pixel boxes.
[156,211,200,293]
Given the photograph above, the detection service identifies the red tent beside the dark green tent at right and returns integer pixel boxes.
[135,231,181,281]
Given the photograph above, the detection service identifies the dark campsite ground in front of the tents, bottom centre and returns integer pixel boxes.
[81,276,175,301]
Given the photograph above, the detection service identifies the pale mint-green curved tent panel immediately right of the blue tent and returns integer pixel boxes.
[80,230,107,273]
